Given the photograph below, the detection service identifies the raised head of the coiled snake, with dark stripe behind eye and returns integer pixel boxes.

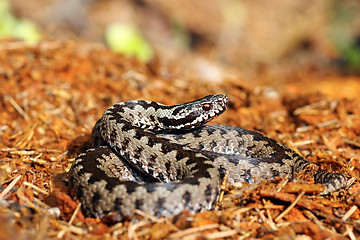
[161,94,229,130]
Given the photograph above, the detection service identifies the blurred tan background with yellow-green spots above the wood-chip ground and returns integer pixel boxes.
[0,0,360,83]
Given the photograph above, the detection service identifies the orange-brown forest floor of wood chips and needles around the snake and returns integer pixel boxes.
[0,41,360,240]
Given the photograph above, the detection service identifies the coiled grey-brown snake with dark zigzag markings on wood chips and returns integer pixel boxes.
[68,94,347,222]
